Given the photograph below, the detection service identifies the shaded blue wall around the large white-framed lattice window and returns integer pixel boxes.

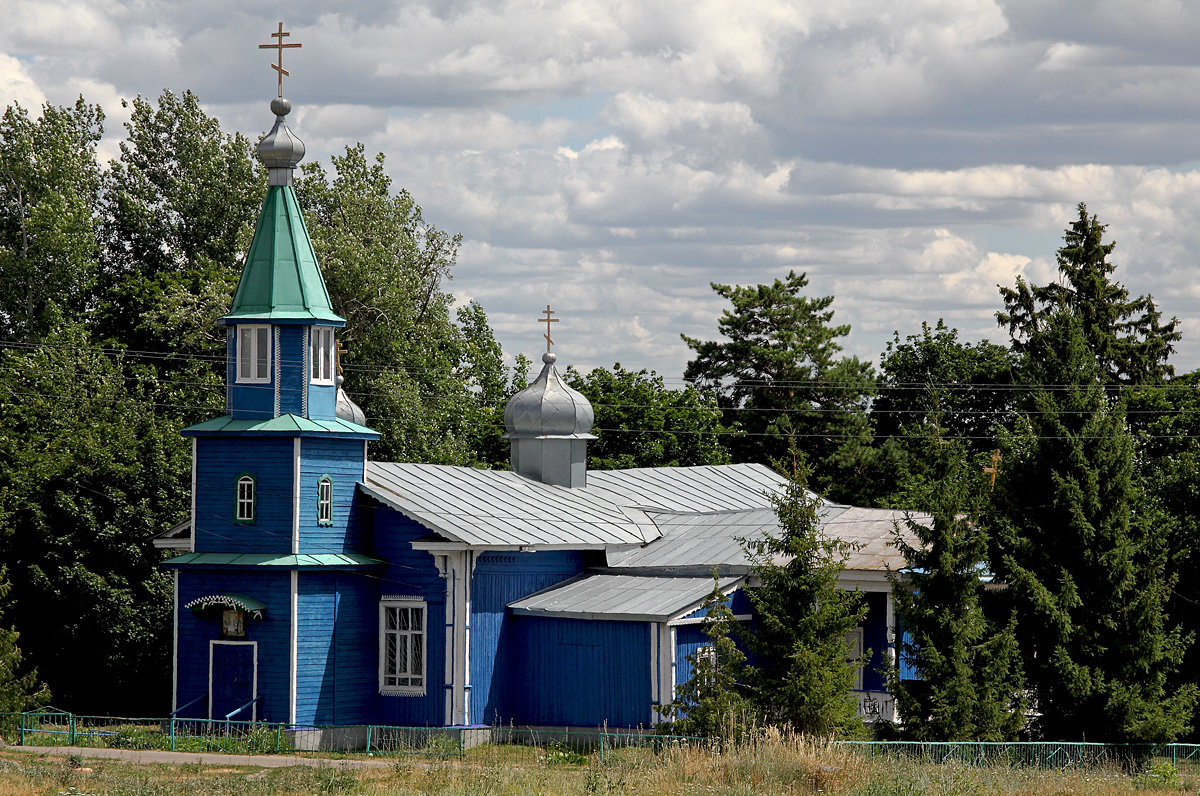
[362,506,445,726]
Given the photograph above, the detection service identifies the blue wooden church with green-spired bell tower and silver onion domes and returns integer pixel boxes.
[158,91,901,726]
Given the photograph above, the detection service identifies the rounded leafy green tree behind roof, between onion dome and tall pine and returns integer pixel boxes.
[566,363,730,469]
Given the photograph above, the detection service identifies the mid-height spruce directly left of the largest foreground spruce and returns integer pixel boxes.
[889,437,1025,741]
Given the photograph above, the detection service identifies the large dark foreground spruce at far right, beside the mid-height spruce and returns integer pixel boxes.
[988,310,1196,741]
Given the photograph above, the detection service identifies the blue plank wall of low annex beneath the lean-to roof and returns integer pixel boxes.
[505,616,653,728]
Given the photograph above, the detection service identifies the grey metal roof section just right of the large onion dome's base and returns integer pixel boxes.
[587,465,787,513]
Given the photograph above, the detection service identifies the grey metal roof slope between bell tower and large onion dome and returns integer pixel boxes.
[360,462,659,547]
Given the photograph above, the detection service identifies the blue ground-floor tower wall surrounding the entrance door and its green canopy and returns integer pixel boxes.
[178,569,290,722]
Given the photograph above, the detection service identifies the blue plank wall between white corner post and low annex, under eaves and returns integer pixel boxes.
[470,550,583,724]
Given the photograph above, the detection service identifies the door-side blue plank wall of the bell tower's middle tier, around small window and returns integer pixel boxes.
[196,436,292,555]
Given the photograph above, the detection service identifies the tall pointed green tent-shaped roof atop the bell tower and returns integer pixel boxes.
[222,185,346,325]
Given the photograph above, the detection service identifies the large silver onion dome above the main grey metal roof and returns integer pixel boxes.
[504,352,595,439]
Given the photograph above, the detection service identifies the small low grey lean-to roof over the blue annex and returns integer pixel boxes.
[509,575,742,622]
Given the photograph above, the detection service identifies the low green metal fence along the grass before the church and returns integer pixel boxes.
[0,708,1200,768]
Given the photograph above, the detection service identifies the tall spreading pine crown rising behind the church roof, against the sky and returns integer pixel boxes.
[683,271,874,499]
